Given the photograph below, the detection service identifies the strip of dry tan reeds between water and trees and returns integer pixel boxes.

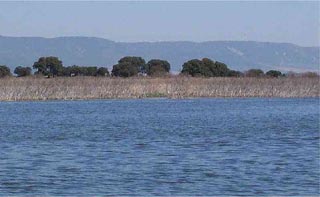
[0,77,320,101]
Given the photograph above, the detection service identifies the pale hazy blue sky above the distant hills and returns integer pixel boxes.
[0,1,320,46]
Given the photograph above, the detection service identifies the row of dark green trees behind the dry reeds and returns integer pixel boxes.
[0,56,318,77]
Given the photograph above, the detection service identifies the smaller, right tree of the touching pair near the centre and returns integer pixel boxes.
[146,59,170,76]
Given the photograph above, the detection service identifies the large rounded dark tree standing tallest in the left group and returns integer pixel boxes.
[33,56,63,77]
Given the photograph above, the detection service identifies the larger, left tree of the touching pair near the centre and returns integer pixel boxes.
[112,56,146,77]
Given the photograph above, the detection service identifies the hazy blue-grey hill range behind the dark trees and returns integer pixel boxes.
[0,36,320,72]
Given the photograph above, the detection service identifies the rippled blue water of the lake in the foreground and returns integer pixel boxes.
[0,99,320,196]
